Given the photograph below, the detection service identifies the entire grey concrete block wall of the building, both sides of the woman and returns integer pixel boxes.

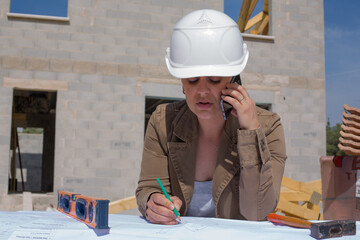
[0,0,325,210]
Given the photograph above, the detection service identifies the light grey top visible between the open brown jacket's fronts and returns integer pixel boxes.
[186,181,216,217]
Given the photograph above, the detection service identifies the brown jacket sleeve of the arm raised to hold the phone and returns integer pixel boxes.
[238,114,286,221]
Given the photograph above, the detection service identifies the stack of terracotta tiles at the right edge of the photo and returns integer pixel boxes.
[338,104,360,156]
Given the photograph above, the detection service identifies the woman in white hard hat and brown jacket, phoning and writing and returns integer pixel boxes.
[136,10,286,224]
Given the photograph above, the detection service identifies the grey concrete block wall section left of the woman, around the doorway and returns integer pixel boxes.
[0,0,223,210]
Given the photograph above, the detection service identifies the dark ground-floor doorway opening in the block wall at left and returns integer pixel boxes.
[9,90,57,193]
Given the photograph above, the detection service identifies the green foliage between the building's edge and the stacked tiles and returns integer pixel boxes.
[326,121,345,156]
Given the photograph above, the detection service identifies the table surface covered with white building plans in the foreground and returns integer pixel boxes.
[0,211,360,240]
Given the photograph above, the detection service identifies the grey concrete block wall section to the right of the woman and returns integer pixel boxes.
[243,0,326,181]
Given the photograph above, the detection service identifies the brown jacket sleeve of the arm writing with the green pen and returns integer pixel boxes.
[135,106,170,216]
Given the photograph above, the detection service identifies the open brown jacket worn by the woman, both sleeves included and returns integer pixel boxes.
[136,101,286,220]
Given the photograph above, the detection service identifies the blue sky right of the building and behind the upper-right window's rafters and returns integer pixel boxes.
[224,0,360,126]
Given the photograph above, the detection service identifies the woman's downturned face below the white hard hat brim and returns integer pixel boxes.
[181,77,231,119]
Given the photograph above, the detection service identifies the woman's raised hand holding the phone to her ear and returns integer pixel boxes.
[222,83,260,130]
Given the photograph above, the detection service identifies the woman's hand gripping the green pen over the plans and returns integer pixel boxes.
[146,193,182,225]
